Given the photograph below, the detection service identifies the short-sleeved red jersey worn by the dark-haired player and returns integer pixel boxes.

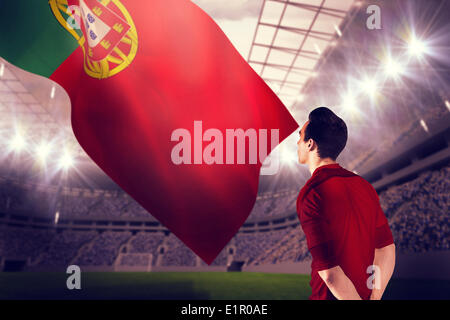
[297,163,394,300]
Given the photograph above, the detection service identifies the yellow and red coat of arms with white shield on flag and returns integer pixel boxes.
[50,0,138,79]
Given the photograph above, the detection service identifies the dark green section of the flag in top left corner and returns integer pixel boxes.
[0,0,78,77]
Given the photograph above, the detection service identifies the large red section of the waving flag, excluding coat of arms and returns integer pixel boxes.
[51,0,298,264]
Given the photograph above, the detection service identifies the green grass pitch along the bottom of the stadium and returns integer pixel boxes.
[0,272,450,300]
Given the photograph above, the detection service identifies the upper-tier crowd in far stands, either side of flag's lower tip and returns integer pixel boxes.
[0,180,298,220]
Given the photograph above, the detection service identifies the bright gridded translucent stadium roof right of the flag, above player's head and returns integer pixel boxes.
[247,0,360,107]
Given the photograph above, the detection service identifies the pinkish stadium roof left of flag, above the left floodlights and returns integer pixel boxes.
[0,58,84,155]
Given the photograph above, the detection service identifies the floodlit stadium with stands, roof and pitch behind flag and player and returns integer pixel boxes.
[0,0,450,300]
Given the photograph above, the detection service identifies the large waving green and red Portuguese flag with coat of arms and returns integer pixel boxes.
[0,0,298,264]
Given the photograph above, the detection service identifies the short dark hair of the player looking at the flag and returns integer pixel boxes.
[304,107,348,161]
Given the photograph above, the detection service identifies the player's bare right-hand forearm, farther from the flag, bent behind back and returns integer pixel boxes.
[370,243,395,300]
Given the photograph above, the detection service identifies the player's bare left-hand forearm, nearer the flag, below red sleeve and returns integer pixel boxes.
[319,266,362,300]
